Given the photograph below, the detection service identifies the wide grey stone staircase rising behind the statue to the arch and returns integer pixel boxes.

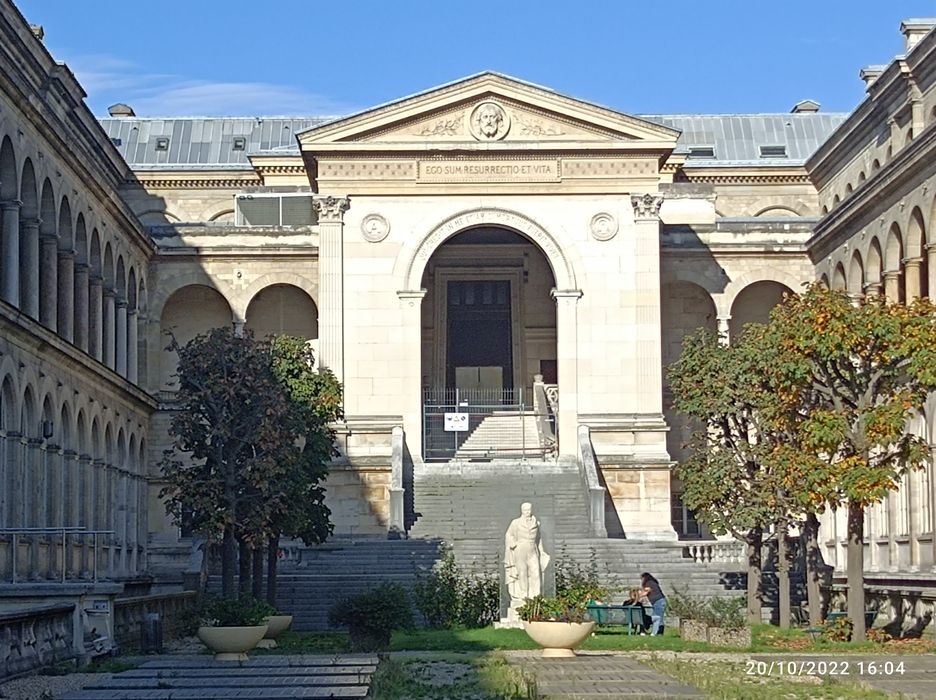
[241,460,744,630]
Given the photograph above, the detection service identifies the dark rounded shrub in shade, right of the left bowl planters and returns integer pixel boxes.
[328,582,413,652]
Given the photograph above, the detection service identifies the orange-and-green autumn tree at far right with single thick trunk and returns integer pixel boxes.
[770,285,936,641]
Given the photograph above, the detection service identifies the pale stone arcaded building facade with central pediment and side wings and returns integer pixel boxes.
[0,0,936,600]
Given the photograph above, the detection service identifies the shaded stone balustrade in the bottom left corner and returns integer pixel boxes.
[0,603,78,679]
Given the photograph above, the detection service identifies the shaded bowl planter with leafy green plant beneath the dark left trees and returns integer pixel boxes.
[198,596,269,661]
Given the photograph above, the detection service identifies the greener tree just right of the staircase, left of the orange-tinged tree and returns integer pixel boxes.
[669,325,796,626]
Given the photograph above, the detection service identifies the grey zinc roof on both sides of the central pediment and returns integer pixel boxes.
[100,112,848,170]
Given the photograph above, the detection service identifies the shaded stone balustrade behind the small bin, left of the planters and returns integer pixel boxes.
[114,591,198,653]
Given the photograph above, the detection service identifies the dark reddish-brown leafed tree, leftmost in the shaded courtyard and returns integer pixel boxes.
[160,328,298,595]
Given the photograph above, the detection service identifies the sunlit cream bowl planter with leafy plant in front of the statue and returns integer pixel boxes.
[517,587,604,658]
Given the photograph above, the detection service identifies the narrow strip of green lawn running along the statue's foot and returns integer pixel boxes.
[266,625,936,654]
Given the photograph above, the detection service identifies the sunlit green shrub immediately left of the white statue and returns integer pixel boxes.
[413,545,500,629]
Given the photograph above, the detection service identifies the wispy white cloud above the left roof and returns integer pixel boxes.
[58,53,358,116]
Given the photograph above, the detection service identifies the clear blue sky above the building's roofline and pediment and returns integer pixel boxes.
[17,0,936,116]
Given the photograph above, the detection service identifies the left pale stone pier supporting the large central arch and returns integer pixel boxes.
[397,289,426,458]
